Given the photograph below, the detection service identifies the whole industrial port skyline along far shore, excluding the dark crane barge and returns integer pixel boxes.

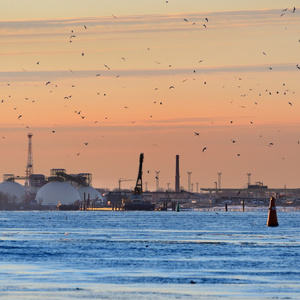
[0,133,300,210]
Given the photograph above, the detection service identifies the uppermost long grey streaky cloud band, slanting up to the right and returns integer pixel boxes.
[0,9,299,37]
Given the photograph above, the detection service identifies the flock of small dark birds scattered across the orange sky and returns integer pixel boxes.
[1,5,300,180]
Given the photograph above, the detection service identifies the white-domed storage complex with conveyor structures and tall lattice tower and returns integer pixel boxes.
[0,133,103,208]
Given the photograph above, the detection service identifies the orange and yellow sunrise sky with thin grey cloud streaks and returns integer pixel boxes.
[0,0,300,191]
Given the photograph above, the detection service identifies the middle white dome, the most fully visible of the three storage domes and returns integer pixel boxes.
[35,181,80,205]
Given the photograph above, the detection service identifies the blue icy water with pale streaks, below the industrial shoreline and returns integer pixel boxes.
[0,211,300,299]
